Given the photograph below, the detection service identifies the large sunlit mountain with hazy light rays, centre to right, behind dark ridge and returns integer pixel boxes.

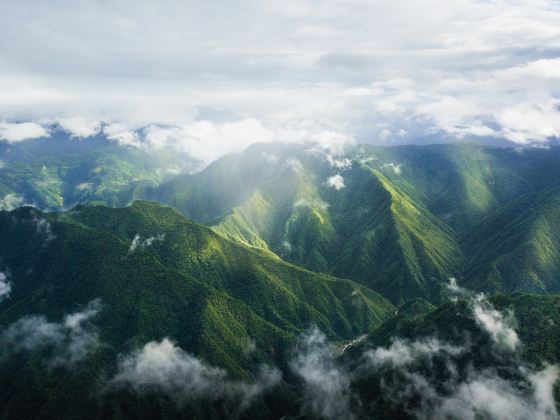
[139,143,560,304]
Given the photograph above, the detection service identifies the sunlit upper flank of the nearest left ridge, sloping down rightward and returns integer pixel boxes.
[72,202,391,337]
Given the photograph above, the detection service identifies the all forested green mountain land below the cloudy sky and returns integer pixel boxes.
[0,139,560,419]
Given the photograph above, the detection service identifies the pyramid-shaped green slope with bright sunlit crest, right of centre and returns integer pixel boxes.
[333,167,461,303]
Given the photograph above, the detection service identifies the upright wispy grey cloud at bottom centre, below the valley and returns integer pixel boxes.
[290,327,355,419]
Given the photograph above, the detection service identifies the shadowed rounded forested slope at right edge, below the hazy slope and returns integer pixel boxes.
[463,188,560,293]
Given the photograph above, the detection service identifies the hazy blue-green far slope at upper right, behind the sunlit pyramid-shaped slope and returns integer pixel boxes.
[352,143,560,235]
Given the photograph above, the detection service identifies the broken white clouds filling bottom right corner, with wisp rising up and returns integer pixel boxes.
[356,279,560,420]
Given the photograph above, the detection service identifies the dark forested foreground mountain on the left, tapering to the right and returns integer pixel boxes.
[0,202,394,418]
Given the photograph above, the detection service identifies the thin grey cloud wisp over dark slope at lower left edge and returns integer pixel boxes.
[0,299,101,367]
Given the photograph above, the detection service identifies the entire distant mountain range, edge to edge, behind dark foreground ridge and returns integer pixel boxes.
[6,139,560,304]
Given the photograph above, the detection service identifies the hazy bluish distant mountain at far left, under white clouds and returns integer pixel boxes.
[0,130,197,210]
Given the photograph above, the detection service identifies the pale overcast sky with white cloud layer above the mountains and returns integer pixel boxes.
[0,0,560,158]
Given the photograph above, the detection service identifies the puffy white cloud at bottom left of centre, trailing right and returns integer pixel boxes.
[111,338,281,409]
